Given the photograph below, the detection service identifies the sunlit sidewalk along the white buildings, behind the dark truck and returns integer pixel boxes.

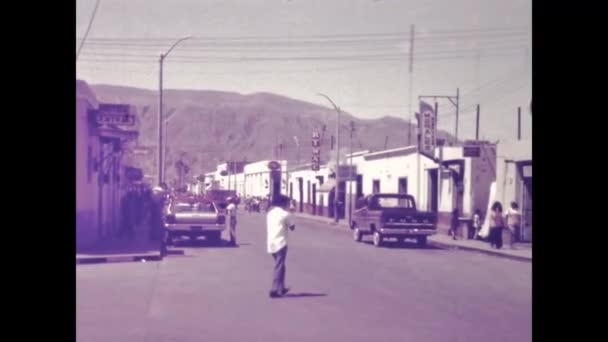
[293,213,532,262]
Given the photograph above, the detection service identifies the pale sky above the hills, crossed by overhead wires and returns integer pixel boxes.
[76,0,532,141]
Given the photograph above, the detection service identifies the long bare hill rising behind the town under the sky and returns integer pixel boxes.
[91,85,453,183]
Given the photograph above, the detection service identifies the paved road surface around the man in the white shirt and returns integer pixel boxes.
[77,214,532,342]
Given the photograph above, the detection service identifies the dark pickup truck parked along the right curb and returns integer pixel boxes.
[351,194,437,247]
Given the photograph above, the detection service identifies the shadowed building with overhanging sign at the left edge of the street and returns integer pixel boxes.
[76,80,139,248]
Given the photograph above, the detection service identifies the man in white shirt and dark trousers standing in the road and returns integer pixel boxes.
[266,195,295,298]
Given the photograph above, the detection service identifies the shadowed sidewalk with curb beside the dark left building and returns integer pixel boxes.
[76,226,162,264]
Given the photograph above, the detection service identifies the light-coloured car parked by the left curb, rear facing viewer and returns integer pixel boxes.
[165,198,226,245]
